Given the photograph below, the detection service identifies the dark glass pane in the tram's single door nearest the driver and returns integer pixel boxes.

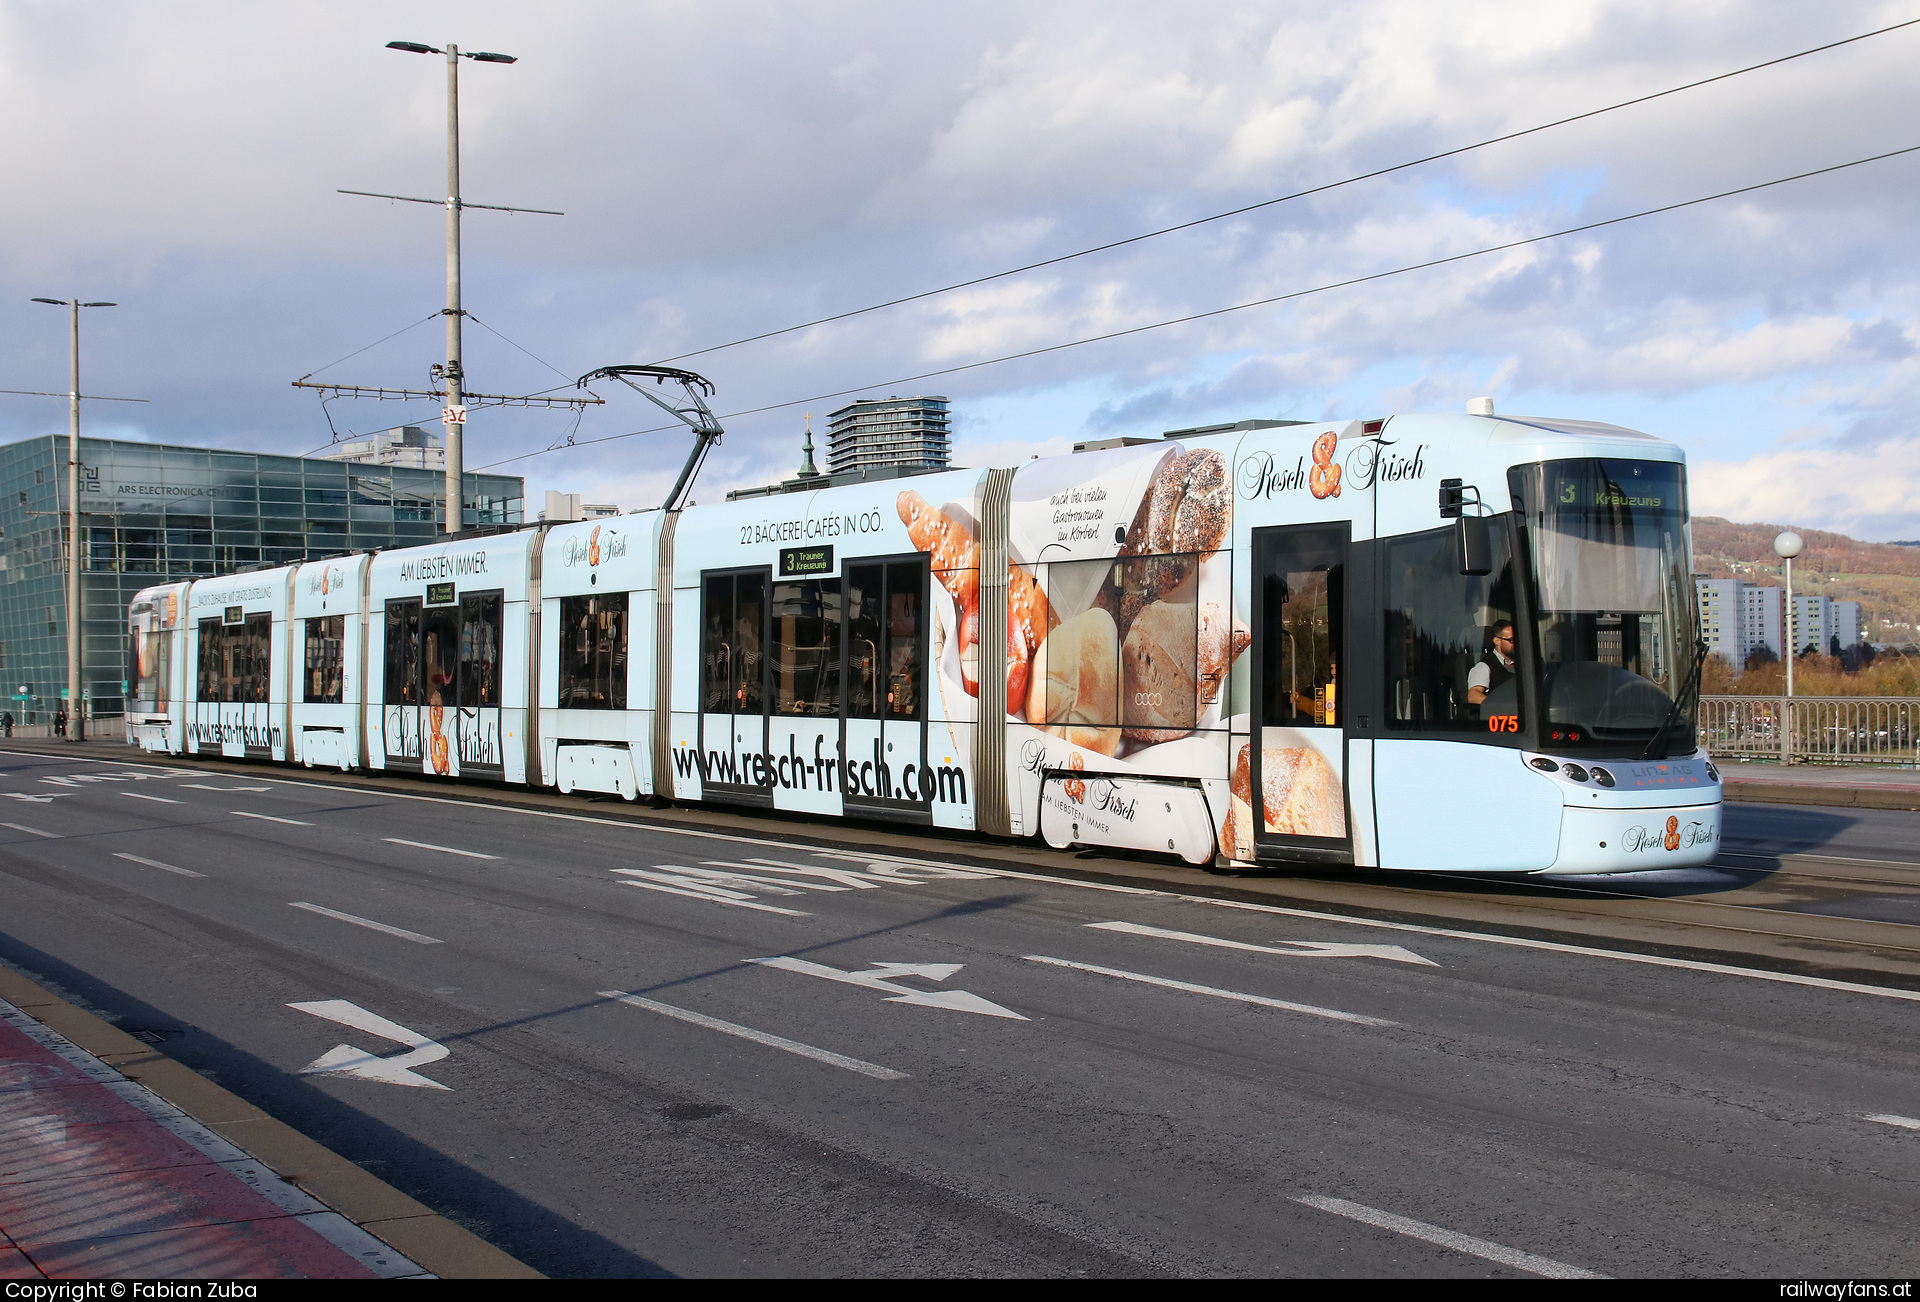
[1254,530,1346,728]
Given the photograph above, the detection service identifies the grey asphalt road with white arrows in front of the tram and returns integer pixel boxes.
[0,753,1920,1277]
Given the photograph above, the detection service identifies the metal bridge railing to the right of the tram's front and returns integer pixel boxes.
[1699,697,1920,764]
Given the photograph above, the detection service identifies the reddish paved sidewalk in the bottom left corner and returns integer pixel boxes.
[0,1001,428,1279]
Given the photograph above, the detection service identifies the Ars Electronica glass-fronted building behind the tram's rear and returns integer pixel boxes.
[0,434,526,722]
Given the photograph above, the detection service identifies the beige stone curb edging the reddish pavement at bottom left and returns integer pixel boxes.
[0,968,545,1279]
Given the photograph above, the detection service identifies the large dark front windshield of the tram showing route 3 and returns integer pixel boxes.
[1511,457,1697,753]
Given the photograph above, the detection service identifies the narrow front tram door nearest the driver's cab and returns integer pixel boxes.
[1233,520,1354,862]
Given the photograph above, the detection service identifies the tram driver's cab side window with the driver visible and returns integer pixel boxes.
[1384,517,1521,737]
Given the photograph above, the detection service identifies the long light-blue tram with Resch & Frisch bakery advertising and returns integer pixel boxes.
[127,415,1722,874]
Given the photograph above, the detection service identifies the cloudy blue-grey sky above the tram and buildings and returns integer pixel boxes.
[0,0,1920,540]
